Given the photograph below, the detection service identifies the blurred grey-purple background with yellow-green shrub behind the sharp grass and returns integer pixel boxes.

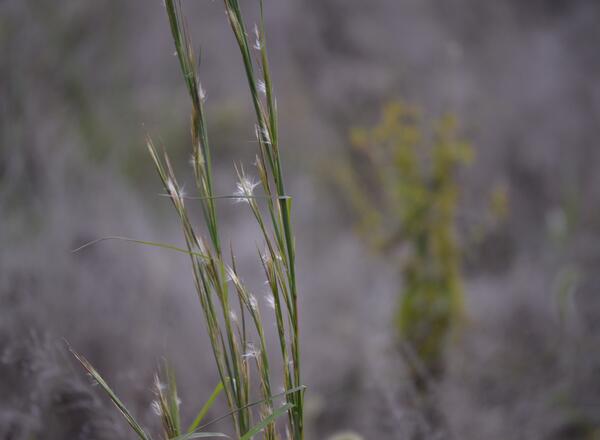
[0,0,600,440]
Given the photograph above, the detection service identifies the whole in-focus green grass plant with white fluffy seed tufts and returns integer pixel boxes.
[76,0,304,440]
